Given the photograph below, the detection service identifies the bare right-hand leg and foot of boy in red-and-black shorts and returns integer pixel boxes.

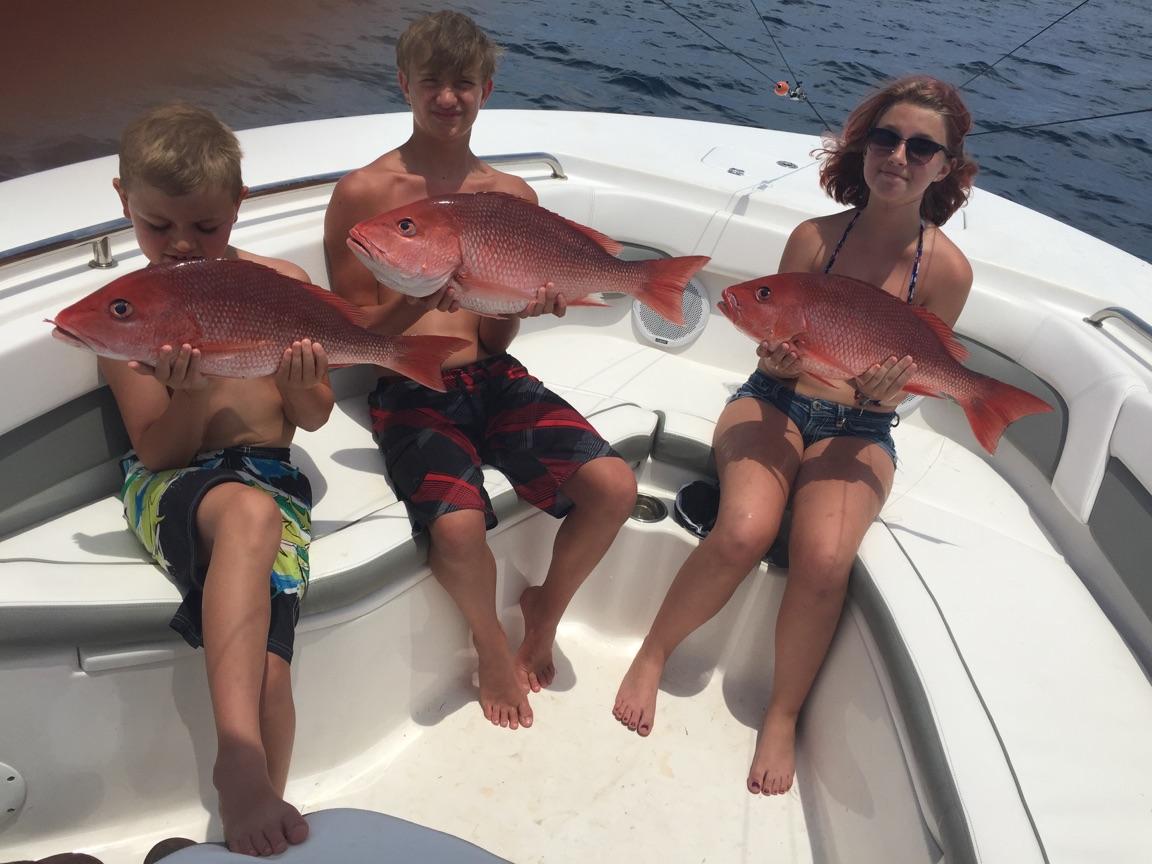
[516,457,636,692]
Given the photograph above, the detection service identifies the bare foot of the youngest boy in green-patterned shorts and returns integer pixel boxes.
[212,748,308,855]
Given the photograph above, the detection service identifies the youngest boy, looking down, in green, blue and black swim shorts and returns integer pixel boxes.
[99,105,333,855]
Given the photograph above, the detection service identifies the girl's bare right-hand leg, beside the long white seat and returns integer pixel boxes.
[748,438,894,795]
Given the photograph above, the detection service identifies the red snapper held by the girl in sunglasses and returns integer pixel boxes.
[719,273,1052,453]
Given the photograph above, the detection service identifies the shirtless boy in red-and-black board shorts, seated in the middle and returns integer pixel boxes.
[324,12,636,729]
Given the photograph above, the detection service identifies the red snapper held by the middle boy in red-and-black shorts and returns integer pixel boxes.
[348,192,708,326]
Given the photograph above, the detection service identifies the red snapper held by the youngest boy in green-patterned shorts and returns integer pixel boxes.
[50,259,468,391]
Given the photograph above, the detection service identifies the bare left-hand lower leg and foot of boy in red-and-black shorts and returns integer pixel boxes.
[429,510,532,729]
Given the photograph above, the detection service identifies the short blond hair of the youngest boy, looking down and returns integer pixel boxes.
[120,103,244,199]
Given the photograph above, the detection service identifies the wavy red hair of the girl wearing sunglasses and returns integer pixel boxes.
[817,75,979,225]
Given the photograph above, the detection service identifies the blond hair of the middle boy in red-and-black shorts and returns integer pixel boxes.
[396,10,501,82]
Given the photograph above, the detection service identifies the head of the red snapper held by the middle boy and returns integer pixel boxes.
[348,199,462,297]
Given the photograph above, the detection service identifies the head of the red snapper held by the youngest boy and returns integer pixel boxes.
[50,265,199,363]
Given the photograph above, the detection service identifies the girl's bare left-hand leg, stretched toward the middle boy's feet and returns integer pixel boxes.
[612,399,802,736]
